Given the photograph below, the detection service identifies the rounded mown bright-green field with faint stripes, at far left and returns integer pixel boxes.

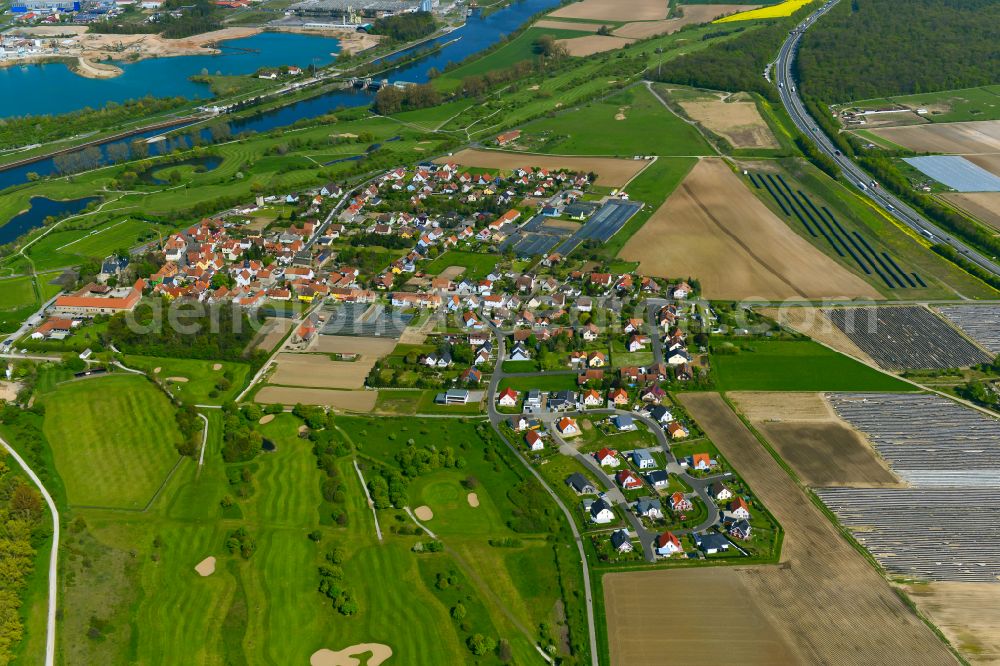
[44,376,181,509]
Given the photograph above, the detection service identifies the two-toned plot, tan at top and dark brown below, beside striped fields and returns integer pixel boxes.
[727,392,902,488]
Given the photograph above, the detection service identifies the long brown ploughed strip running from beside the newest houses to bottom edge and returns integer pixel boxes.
[676,393,955,665]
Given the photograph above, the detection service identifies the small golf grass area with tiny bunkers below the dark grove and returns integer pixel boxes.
[124,356,250,405]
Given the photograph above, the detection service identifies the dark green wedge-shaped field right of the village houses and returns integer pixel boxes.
[712,340,913,391]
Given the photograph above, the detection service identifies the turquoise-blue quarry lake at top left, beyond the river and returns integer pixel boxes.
[0,32,340,117]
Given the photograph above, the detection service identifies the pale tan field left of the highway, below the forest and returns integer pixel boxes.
[664,88,781,149]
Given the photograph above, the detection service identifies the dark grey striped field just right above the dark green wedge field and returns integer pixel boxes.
[826,305,993,370]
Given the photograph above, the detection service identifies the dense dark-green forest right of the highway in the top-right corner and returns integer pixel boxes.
[795,0,1000,103]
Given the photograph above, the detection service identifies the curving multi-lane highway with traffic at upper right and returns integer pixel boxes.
[765,0,1000,275]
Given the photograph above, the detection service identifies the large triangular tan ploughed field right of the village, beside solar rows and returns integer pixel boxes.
[619,158,882,300]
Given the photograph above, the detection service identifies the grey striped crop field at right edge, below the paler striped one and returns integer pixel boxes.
[816,488,1000,580]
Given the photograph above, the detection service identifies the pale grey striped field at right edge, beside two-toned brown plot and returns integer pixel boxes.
[830,393,1000,490]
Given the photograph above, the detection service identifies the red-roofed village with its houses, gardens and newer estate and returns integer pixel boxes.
[8,144,777,563]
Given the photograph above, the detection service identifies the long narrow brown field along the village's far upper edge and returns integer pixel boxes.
[435,148,649,187]
